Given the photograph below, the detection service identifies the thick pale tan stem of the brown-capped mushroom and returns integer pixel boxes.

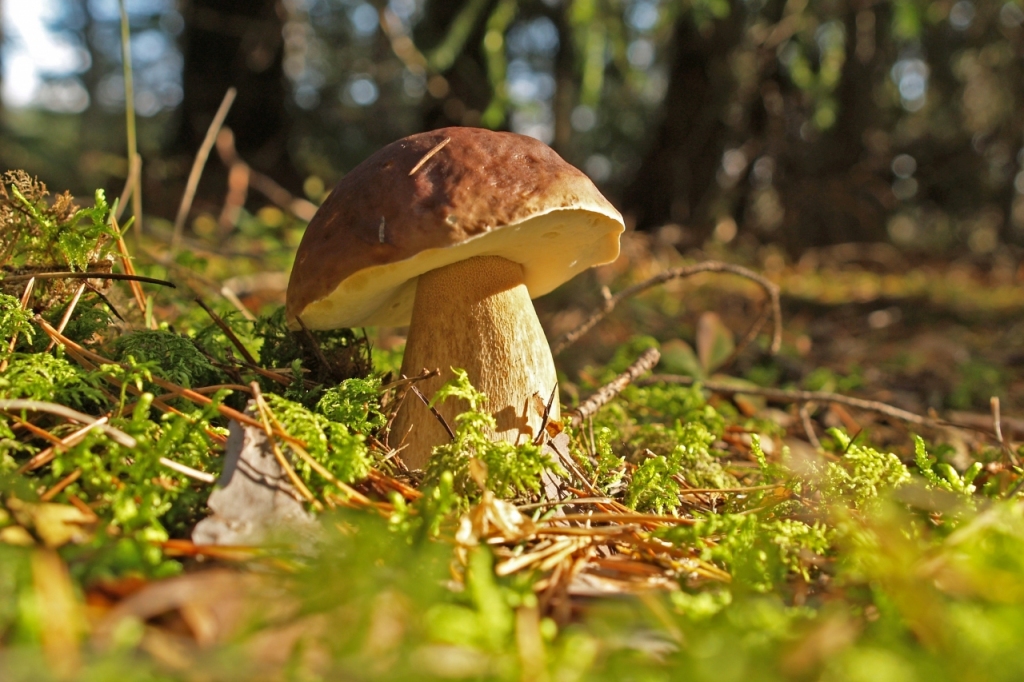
[389,256,559,468]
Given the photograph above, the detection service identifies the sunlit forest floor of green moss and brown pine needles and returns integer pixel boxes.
[0,180,1024,682]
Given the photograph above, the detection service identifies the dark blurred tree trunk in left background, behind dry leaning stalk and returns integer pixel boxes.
[171,0,302,191]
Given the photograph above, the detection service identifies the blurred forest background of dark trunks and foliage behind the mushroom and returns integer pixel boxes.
[0,0,1024,258]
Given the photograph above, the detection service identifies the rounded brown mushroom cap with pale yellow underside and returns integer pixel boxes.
[287,128,624,329]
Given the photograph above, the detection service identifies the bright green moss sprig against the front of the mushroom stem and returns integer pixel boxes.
[426,369,555,498]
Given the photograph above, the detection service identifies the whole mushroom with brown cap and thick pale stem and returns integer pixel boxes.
[287,128,624,468]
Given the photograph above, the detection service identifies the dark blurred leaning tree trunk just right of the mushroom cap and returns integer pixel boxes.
[622,2,744,236]
